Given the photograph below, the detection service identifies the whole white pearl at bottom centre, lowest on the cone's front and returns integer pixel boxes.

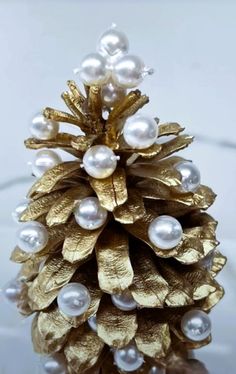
[114,344,144,372]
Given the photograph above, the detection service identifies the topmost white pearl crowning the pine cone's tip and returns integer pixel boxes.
[97,27,129,57]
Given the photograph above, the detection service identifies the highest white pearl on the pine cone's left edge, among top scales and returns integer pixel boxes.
[30,113,59,140]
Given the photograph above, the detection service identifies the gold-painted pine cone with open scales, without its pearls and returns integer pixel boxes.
[12,81,226,374]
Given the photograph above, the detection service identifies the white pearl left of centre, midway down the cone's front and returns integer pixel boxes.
[74,197,107,230]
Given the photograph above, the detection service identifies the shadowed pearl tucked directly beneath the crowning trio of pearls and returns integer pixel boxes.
[101,82,126,108]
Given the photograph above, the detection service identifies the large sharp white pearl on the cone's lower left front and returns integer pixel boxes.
[57,283,91,317]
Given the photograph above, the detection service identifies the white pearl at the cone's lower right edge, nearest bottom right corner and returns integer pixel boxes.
[181,309,211,342]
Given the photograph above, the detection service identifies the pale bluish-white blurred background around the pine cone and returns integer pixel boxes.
[0,0,236,374]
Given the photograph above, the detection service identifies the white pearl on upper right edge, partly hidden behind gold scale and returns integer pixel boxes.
[175,161,201,192]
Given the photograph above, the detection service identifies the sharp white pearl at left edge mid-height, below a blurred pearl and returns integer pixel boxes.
[17,221,48,252]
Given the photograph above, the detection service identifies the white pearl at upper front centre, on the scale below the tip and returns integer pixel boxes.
[83,145,117,179]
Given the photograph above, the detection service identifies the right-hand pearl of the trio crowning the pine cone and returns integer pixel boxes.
[112,55,145,88]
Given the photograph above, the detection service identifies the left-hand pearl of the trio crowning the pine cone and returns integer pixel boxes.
[79,53,110,86]
